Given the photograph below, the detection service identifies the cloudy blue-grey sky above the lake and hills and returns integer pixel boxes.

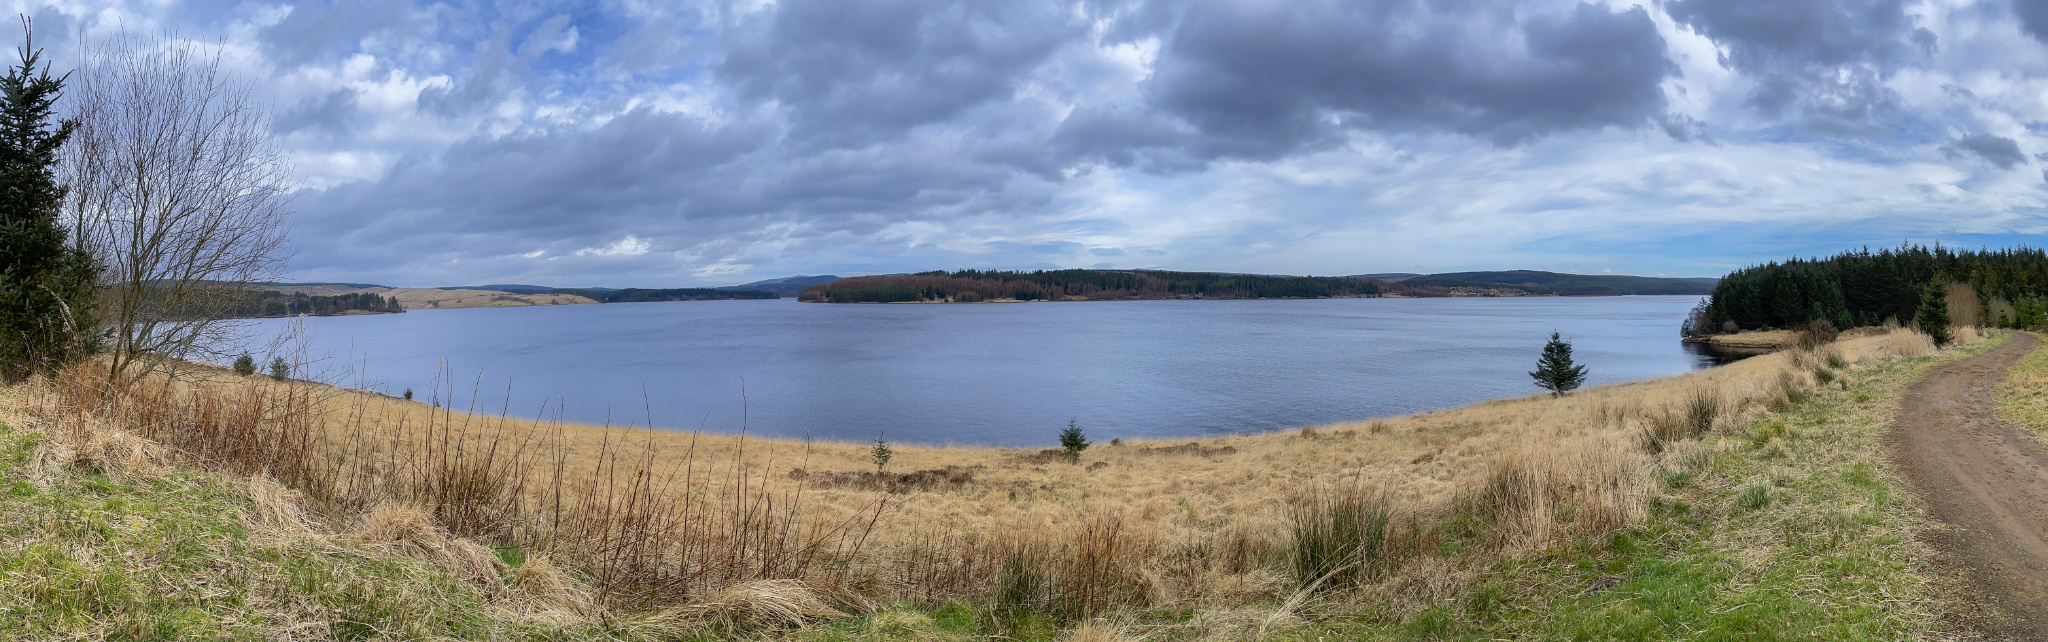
[14,0,2048,287]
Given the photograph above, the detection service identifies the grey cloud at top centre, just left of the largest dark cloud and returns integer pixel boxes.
[717,0,1085,146]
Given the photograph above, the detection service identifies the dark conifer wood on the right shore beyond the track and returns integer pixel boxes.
[1688,244,2048,334]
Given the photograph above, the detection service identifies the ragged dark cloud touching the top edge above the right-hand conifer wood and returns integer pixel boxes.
[1665,0,1937,135]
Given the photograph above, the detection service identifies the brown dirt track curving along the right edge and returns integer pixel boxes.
[1892,332,2048,640]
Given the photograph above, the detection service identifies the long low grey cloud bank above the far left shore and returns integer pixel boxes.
[297,109,1049,279]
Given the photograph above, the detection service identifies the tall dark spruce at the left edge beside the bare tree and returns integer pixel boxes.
[0,28,98,379]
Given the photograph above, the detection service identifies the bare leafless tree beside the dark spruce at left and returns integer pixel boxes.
[63,35,291,373]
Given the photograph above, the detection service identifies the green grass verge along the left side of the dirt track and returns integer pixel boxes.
[1286,336,1998,640]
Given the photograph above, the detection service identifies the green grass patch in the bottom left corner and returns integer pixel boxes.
[0,414,629,642]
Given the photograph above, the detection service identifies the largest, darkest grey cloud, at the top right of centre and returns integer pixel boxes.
[1061,0,1677,168]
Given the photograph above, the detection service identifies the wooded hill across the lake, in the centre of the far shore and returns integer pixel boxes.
[797,269,1441,304]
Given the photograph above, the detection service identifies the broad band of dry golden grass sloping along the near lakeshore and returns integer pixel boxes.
[4,330,1976,638]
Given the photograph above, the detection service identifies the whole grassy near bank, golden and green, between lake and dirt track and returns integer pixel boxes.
[0,328,2034,640]
